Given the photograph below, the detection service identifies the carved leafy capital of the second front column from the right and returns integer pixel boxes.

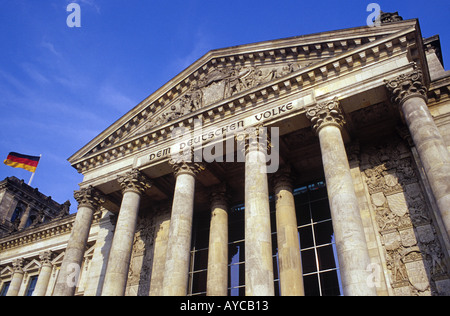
[306,97,346,134]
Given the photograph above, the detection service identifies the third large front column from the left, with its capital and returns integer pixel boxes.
[163,157,204,296]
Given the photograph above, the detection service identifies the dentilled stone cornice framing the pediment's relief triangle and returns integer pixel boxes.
[69,20,418,173]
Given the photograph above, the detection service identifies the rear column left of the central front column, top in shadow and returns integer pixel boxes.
[206,185,228,296]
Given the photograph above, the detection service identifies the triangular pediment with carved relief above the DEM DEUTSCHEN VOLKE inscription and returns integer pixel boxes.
[69,20,417,172]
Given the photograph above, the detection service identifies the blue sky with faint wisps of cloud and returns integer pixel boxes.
[0,0,450,212]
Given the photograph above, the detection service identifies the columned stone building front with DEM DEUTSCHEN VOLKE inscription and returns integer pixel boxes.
[0,13,450,296]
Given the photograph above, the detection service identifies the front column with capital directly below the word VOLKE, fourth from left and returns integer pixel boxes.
[236,127,275,296]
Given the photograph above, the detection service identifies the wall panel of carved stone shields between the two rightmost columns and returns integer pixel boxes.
[360,139,449,295]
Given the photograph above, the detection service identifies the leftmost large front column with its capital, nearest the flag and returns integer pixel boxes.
[53,186,105,296]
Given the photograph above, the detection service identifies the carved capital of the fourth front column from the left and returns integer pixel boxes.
[235,124,272,155]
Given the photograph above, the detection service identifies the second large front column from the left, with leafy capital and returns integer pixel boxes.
[102,169,151,296]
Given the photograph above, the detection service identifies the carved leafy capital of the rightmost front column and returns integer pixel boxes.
[384,69,428,105]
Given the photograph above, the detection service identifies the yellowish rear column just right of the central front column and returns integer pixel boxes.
[272,167,305,296]
